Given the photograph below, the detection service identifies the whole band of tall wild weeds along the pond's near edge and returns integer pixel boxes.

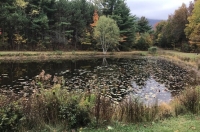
[0,85,200,131]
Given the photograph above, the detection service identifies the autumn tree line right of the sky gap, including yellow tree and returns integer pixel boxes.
[154,0,200,52]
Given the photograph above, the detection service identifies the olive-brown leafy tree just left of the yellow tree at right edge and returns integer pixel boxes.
[154,4,189,49]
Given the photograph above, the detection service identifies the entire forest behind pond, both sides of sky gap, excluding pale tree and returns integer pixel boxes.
[0,0,200,52]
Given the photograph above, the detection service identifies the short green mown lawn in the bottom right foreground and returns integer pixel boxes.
[80,115,200,132]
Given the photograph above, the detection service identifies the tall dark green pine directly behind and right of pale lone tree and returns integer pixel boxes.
[102,0,136,50]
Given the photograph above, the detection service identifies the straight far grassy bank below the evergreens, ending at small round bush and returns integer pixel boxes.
[0,51,147,61]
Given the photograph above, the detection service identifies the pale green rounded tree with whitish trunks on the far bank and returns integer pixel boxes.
[94,16,120,54]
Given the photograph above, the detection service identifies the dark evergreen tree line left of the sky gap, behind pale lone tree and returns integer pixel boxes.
[0,0,152,50]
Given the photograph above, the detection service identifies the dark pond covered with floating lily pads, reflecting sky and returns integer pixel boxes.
[0,57,189,103]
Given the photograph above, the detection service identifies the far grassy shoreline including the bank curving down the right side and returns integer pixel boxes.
[0,49,200,78]
